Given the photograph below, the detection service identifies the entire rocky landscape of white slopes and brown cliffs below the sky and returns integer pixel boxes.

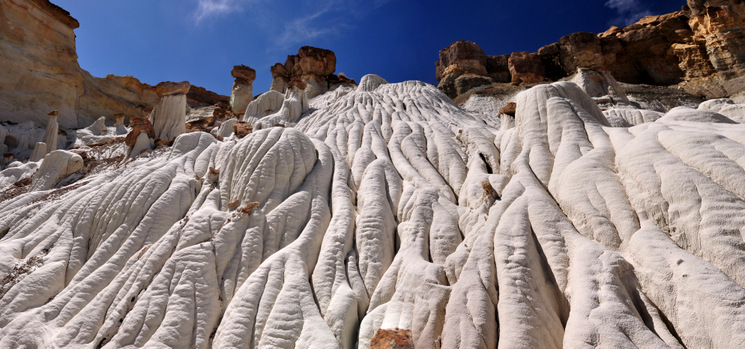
[0,0,745,348]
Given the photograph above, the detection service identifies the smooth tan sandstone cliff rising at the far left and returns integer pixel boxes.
[0,0,227,128]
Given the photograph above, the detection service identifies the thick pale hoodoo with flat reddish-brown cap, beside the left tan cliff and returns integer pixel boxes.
[150,81,191,141]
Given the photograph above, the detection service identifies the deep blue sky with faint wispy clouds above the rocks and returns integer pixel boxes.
[52,0,685,95]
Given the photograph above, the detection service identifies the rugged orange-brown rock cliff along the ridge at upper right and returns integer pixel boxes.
[435,0,745,98]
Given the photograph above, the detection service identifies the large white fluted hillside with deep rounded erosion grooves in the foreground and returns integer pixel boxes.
[0,76,745,348]
